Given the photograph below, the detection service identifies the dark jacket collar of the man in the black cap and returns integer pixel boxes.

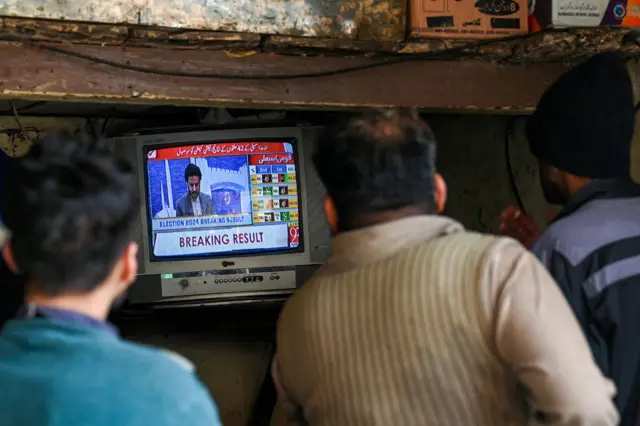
[553,179,640,222]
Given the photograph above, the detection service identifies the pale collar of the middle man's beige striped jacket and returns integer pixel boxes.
[318,215,464,275]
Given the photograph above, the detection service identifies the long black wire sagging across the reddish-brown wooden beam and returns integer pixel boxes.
[26,28,569,80]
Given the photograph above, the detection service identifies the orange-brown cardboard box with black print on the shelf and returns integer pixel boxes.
[410,0,529,39]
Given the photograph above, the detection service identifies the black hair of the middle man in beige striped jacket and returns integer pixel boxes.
[313,110,436,230]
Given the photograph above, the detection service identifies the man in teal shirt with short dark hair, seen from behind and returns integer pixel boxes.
[0,136,220,426]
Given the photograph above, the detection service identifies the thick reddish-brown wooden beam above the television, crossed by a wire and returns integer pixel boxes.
[0,43,565,113]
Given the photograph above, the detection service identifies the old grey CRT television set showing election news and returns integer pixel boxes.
[113,127,330,307]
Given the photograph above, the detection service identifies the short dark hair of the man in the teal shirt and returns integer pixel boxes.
[2,134,138,296]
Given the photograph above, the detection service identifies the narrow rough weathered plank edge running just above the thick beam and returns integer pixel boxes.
[5,17,640,64]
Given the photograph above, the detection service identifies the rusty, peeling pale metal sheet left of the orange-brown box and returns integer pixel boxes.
[0,0,407,42]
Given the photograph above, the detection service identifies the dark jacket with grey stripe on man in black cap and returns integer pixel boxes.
[532,180,640,426]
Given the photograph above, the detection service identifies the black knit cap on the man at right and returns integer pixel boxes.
[527,53,635,179]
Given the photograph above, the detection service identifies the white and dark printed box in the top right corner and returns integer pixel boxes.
[529,0,640,31]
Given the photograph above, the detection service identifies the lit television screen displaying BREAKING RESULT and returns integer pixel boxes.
[146,141,302,261]
